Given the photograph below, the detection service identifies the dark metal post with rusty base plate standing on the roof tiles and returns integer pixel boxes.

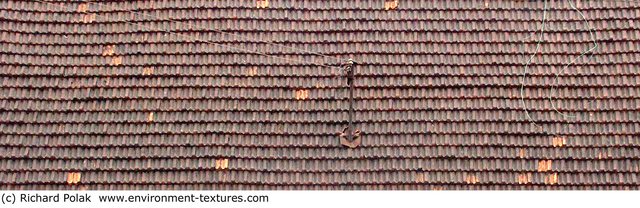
[340,59,362,148]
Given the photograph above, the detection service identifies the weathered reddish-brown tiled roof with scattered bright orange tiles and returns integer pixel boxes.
[0,0,640,190]
